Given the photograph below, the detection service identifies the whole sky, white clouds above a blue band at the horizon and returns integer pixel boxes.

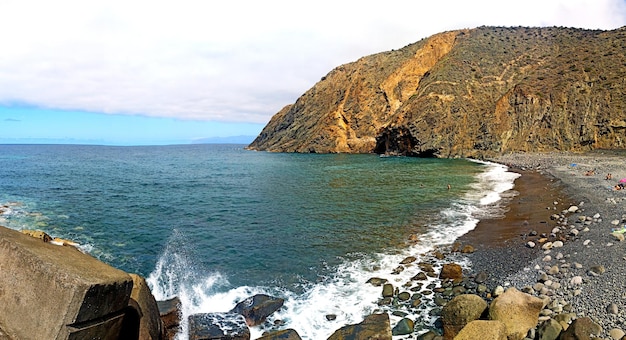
[0,0,626,145]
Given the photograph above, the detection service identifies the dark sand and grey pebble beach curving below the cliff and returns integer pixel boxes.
[458,150,626,338]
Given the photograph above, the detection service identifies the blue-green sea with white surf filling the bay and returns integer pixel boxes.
[0,144,518,339]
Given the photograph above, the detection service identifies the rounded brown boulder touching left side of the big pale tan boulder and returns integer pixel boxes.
[441,294,487,339]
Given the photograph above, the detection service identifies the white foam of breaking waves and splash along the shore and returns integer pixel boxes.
[147,162,519,340]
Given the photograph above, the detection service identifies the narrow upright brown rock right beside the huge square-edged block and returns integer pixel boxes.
[124,274,165,340]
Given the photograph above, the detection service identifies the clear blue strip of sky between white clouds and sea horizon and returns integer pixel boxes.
[0,107,263,145]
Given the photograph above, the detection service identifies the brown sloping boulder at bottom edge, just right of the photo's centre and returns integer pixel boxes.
[328,314,392,340]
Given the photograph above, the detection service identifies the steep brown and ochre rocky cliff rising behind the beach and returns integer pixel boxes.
[248,27,626,157]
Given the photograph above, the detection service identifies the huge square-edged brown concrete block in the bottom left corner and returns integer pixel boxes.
[0,227,133,339]
